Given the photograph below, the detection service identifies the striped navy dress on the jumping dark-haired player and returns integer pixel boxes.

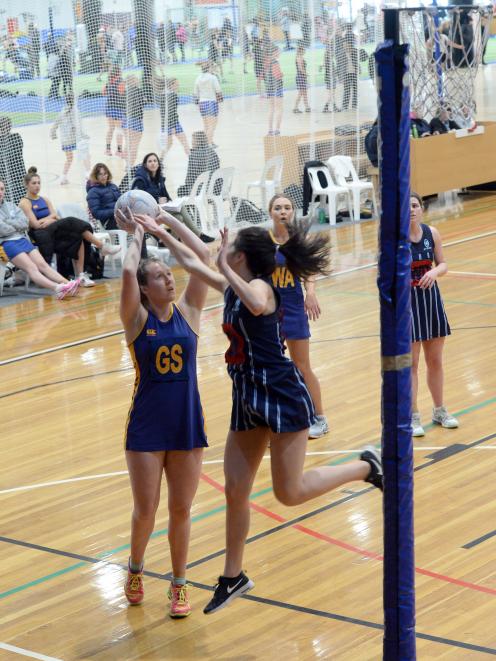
[222,287,315,434]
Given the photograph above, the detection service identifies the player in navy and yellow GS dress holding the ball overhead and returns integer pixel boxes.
[116,208,209,617]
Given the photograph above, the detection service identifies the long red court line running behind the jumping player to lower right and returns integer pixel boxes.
[201,473,496,595]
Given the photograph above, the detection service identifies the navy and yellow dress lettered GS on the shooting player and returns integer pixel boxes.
[125,305,208,452]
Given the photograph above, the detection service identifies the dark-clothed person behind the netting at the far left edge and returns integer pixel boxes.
[0,117,26,204]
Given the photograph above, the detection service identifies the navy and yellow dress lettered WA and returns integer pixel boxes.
[272,237,310,340]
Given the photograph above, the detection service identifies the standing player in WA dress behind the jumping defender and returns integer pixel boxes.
[269,195,329,438]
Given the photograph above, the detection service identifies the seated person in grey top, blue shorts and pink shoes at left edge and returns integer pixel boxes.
[0,179,80,299]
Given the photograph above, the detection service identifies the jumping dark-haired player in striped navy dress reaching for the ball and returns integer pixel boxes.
[137,211,382,614]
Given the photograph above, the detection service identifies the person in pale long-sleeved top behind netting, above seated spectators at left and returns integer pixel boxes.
[50,93,90,185]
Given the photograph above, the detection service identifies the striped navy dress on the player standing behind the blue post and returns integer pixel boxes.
[410,224,451,342]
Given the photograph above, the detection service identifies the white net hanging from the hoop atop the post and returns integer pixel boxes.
[400,6,492,128]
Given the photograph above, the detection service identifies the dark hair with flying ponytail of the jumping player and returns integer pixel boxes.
[234,221,330,278]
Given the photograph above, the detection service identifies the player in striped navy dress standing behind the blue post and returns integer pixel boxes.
[410,193,458,436]
